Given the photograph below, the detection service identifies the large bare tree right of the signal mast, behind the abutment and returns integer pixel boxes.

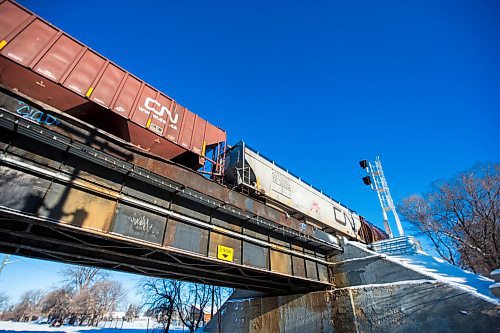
[399,164,500,275]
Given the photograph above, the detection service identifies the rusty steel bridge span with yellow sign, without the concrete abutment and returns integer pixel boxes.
[0,90,341,294]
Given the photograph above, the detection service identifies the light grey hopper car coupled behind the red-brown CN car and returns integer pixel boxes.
[224,142,382,242]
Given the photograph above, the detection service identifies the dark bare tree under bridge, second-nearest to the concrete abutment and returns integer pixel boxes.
[139,278,185,333]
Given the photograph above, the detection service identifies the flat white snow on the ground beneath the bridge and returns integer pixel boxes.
[0,320,201,333]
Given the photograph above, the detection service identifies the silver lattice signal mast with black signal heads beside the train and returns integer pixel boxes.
[359,156,404,238]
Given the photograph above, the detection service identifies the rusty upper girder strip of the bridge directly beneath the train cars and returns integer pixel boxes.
[0,89,339,249]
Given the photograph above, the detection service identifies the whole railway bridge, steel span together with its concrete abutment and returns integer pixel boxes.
[0,90,499,333]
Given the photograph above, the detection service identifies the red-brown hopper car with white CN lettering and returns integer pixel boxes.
[0,1,226,168]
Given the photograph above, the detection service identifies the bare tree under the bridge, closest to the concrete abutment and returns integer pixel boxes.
[175,283,212,332]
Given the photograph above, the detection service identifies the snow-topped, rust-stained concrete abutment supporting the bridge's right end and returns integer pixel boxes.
[205,243,500,333]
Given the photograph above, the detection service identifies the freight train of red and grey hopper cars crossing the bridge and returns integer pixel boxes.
[0,1,387,243]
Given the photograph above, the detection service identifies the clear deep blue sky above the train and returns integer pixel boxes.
[0,0,500,302]
